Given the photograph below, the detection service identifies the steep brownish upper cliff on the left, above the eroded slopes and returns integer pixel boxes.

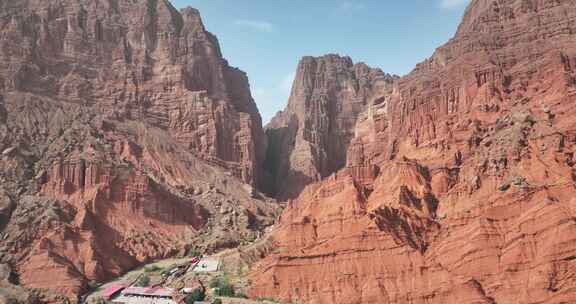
[0,0,266,188]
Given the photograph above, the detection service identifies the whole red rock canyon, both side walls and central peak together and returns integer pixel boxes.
[0,0,576,304]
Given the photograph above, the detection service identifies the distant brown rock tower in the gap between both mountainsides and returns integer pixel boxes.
[265,55,395,199]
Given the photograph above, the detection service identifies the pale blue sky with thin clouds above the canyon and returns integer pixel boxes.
[172,0,469,123]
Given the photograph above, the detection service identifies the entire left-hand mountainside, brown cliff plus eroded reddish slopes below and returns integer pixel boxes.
[0,0,276,299]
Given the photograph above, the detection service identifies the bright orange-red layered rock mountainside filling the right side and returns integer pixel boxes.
[252,0,576,304]
